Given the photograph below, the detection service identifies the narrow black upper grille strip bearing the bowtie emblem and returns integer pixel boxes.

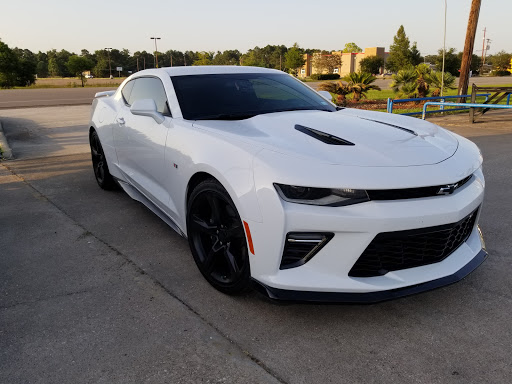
[366,175,472,200]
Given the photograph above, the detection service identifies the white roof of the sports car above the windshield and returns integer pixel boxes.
[132,65,285,76]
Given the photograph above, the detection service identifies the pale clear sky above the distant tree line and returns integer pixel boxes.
[0,0,512,55]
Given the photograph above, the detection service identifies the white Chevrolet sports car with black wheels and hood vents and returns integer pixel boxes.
[89,66,487,302]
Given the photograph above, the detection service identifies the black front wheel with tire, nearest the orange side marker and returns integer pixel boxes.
[187,179,250,294]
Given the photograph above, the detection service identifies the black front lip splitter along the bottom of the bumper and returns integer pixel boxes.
[253,249,488,304]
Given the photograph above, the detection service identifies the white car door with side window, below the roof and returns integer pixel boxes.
[114,77,172,213]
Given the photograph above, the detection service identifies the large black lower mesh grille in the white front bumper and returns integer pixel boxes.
[349,209,478,277]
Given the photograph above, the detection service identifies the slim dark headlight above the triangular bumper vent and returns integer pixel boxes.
[274,183,370,207]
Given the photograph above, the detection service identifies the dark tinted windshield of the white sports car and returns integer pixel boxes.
[171,73,336,120]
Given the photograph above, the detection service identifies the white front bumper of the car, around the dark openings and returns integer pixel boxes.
[249,159,486,296]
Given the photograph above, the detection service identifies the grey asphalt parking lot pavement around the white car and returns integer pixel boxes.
[0,106,512,383]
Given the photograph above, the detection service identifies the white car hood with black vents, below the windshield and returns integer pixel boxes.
[194,108,458,167]
